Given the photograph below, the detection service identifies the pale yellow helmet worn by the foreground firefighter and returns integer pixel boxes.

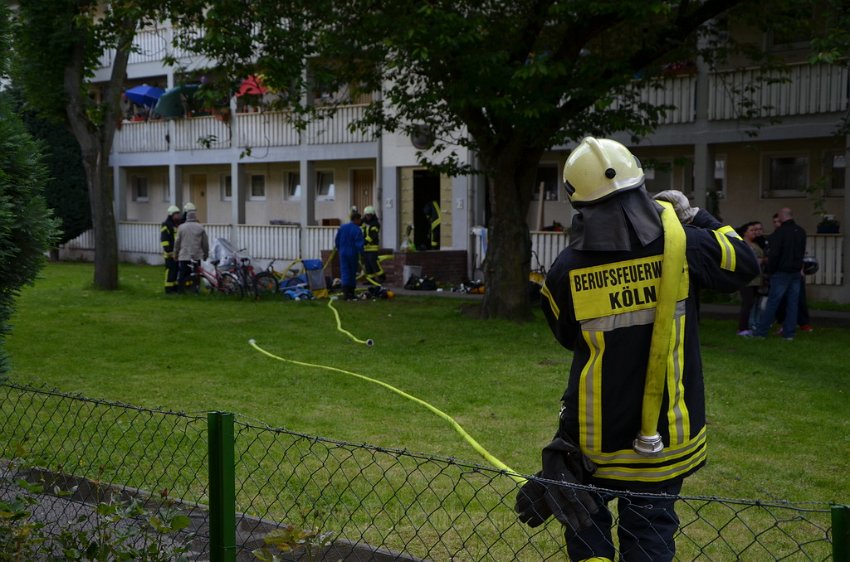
[564,137,644,205]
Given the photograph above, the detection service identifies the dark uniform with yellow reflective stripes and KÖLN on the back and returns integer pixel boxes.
[541,210,759,562]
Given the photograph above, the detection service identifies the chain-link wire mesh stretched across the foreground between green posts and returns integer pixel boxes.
[0,382,850,561]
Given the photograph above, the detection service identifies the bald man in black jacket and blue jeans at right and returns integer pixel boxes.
[753,208,806,340]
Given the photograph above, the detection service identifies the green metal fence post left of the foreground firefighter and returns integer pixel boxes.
[207,412,236,562]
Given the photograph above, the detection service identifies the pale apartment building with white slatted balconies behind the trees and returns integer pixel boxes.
[65,21,850,302]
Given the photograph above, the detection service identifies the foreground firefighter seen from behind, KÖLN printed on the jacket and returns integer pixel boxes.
[516,138,759,562]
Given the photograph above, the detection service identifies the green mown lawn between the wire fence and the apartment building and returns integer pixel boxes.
[6,263,850,559]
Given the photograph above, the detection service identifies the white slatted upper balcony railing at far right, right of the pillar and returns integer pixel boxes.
[709,64,848,119]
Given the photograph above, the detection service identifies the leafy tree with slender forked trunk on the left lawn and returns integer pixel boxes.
[14,0,156,290]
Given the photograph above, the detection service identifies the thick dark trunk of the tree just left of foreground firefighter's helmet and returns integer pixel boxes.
[481,144,542,322]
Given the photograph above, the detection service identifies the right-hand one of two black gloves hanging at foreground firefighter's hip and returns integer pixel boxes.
[540,437,599,530]
